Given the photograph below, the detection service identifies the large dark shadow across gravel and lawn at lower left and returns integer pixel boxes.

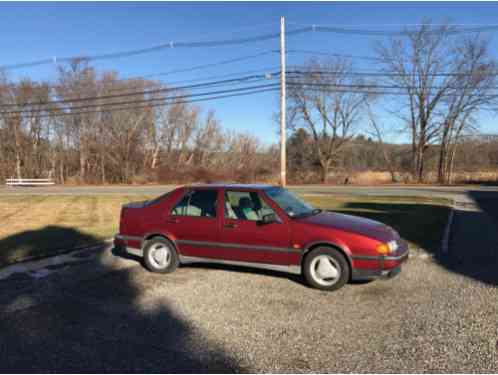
[0,226,244,373]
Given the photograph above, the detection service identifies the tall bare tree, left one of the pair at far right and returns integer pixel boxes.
[377,23,455,182]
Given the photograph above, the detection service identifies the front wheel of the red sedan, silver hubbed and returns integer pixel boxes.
[303,246,351,291]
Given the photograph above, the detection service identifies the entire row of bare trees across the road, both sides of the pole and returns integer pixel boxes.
[0,22,498,184]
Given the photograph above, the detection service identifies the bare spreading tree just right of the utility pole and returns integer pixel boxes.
[288,58,368,182]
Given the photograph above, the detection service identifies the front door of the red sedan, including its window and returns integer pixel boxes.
[220,190,292,265]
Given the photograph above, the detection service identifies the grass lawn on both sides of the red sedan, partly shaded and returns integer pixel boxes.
[0,195,448,267]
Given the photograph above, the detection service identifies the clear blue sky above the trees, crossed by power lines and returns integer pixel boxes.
[0,2,498,144]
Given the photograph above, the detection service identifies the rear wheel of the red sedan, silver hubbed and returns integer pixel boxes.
[144,237,180,273]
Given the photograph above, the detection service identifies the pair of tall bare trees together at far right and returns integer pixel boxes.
[377,22,495,182]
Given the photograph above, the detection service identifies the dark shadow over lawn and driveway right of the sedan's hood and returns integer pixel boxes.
[333,198,498,286]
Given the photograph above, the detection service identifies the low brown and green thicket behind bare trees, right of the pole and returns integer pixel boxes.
[287,128,498,184]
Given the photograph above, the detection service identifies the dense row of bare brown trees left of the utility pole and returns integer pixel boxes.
[0,60,268,184]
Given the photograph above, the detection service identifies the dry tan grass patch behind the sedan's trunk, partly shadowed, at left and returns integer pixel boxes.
[0,195,150,266]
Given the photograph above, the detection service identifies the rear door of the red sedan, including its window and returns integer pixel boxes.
[166,188,223,258]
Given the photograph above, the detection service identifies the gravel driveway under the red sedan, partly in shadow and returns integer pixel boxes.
[0,193,498,373]
